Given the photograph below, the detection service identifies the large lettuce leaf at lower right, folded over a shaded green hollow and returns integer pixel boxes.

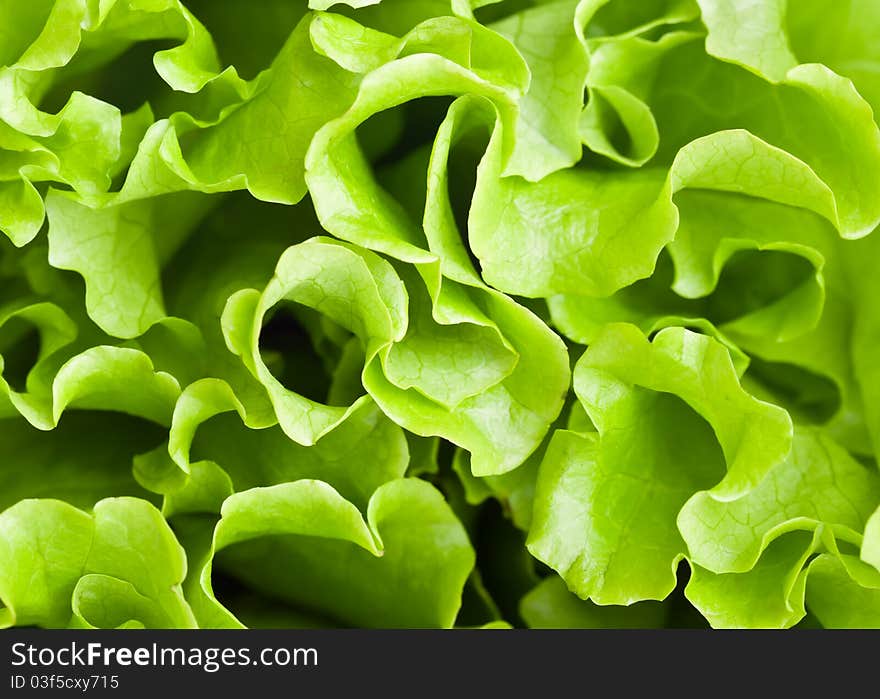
[528,325,792,604]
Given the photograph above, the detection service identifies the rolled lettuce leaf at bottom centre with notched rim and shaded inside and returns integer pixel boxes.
[188,479,474,628]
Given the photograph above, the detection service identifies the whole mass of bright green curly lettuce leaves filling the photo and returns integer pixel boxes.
[0,0,880,628]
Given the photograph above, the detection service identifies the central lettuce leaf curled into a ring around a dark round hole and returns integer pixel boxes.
[223,238,567,475]
